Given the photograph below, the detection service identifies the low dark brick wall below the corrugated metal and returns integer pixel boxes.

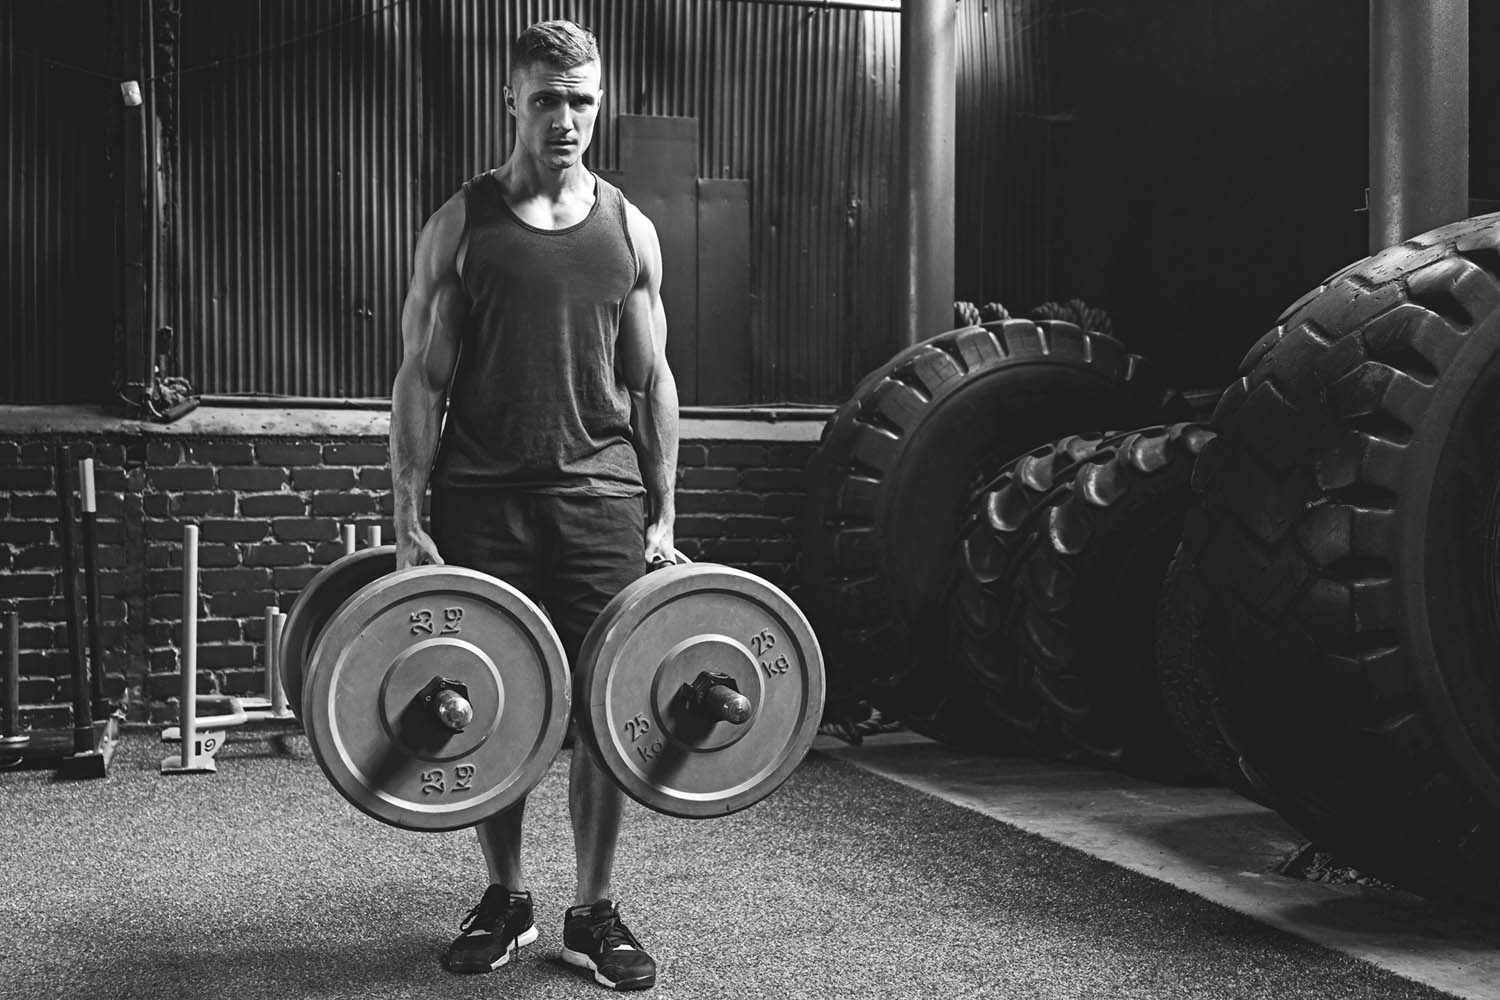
[0,401,821,730]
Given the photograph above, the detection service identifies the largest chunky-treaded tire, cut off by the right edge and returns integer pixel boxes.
[1184,216,1500,904]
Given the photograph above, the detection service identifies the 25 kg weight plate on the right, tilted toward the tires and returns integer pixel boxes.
[576,562,824,819]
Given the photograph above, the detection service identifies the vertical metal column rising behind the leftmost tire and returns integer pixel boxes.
[897,0,959,346]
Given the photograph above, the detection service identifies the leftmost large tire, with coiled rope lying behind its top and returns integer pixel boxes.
[801,319,1169,734]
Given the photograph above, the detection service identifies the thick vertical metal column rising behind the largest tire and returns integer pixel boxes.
[1370,0,1469,252]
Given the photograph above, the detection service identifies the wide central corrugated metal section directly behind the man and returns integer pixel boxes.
[180,0,924,402]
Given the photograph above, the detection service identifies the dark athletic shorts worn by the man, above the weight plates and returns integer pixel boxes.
[432,487,647,669]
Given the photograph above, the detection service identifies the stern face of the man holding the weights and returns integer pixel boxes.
[506,60,605,171]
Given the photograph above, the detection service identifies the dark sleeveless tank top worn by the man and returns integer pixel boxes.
[432,174,645,496]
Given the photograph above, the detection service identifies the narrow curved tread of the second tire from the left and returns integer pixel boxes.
[950,432,1115,756]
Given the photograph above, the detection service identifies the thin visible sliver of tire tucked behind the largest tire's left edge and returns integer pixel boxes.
[1157,550,1271,805]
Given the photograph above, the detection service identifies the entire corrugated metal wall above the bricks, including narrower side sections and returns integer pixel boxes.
[0,0,1056,402]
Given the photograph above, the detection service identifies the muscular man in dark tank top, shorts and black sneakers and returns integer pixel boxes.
[390,21,677,990]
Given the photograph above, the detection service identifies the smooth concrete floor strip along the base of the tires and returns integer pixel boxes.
[815,733,1500,1000]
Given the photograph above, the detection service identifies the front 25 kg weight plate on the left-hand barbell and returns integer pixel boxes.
[302,565,572,831]
